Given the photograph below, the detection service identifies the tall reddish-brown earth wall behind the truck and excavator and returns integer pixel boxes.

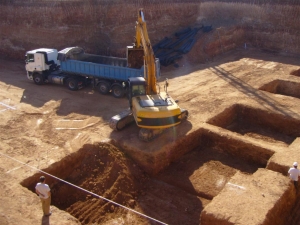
[0,0,300,63]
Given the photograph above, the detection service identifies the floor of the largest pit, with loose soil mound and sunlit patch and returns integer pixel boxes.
[21,133,269,225]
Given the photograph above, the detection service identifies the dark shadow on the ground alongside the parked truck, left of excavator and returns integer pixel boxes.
[20,82,128,118]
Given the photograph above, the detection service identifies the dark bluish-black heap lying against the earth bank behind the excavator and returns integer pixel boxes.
[153,26,212,66]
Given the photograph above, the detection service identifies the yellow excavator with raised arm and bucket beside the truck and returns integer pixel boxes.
[109,9,188,141]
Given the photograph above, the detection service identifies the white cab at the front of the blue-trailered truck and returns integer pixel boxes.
[25,48,59,73]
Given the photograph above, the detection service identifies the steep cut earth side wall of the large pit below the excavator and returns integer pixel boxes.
[127,127,274,176]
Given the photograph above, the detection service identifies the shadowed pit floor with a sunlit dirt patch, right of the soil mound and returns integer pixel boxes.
[155,141,264,200]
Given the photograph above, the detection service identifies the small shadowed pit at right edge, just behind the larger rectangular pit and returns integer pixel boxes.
[259,80,300,98]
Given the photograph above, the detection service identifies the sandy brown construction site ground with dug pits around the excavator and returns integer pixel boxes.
[0,48,300,225]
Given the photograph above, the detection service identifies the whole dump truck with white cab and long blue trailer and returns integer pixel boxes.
[26,47,144,98]
